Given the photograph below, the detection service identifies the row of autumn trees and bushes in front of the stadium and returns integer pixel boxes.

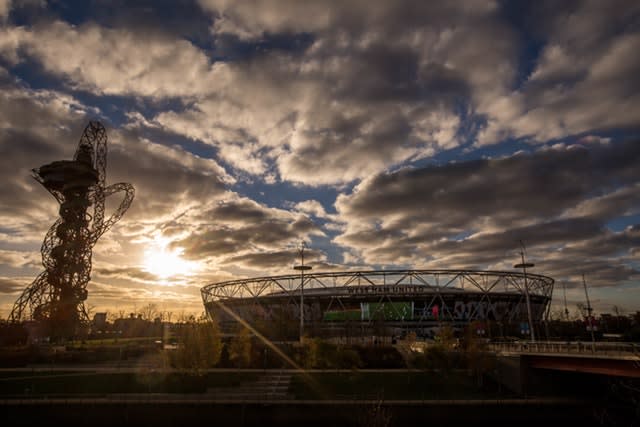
[166,321,490,371]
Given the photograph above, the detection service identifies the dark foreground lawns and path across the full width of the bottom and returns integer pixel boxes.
[0,368,638,427]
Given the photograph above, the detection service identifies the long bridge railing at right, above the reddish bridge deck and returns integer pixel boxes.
[488,341,640,357]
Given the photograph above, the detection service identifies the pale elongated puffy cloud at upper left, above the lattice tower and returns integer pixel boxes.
[0,21,227,98]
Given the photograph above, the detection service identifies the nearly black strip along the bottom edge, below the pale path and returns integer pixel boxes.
[0,396,608,427]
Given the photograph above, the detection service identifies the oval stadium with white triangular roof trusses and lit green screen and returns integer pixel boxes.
[201,270,554,340]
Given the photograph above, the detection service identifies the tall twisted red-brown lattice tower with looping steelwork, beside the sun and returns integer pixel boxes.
[10,121,134,337]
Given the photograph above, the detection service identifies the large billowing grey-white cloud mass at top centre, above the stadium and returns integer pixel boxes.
[156,1,515,185]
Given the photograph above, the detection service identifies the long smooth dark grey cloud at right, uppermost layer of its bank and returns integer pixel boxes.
[337,141,640,227]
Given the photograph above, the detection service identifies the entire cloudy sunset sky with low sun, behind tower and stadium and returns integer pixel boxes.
[0,0,640,317]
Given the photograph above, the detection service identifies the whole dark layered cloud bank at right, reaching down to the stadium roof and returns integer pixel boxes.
[336,141,640,286]
